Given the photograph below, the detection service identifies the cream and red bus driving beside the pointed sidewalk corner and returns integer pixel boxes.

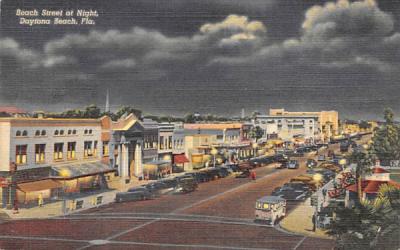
[255,196,286,225]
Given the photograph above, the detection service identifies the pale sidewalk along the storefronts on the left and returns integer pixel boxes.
[0,176,159,221]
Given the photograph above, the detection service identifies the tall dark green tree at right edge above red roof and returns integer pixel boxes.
[371,109,400,163]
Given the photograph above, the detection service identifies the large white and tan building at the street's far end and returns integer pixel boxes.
[253,109,339,142]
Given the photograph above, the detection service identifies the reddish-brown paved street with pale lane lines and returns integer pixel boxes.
[0,153,333,249]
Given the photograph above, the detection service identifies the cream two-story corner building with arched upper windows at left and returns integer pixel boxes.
[0,116,115,208]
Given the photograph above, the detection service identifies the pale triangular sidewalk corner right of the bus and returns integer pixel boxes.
[280,198,332,239]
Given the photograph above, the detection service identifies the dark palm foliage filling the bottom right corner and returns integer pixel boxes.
[328,185,400,249]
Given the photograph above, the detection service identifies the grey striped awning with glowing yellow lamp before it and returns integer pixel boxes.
[51,162,116,179]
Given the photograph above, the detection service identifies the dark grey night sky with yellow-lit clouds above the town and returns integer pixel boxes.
[0,0,400,118]
